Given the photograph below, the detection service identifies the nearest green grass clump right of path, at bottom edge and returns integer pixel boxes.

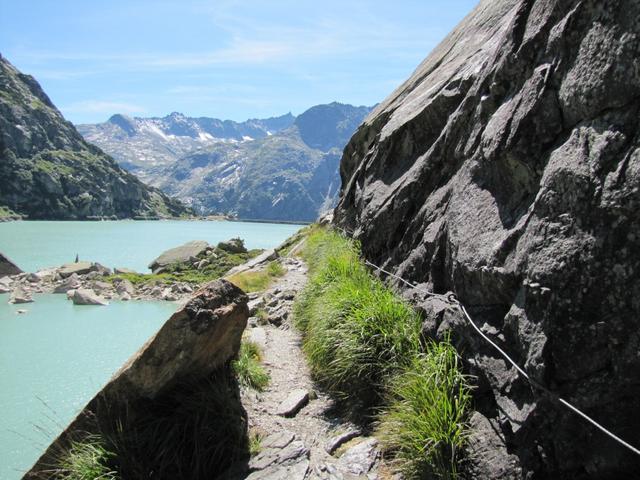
[377,342,471,480]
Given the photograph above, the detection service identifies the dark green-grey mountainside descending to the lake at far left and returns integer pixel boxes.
[0,56,187,219]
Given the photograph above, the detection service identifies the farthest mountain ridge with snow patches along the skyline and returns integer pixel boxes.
[77,112,296,176]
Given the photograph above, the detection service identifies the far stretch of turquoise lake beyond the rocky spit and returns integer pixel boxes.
[0,220,301,273]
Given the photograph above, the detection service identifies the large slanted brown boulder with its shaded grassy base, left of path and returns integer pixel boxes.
[24,280,249,479]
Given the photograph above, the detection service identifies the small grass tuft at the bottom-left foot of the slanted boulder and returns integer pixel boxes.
[55,436,119,480]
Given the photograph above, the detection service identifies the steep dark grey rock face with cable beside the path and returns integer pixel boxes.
[335,0,640,479]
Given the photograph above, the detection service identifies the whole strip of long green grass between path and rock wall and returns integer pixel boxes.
[294,226,470,479]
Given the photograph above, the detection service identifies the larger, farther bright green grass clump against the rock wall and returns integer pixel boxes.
[294,230,421,409]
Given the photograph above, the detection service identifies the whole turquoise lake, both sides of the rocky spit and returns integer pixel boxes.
[0,221,300,480]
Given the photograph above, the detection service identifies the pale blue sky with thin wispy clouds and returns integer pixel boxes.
[0,0,477,123]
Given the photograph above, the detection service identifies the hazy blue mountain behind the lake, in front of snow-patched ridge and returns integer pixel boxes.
[147,103,370,221]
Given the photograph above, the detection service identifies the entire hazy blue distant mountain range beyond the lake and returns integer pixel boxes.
[78,102,371,221]
